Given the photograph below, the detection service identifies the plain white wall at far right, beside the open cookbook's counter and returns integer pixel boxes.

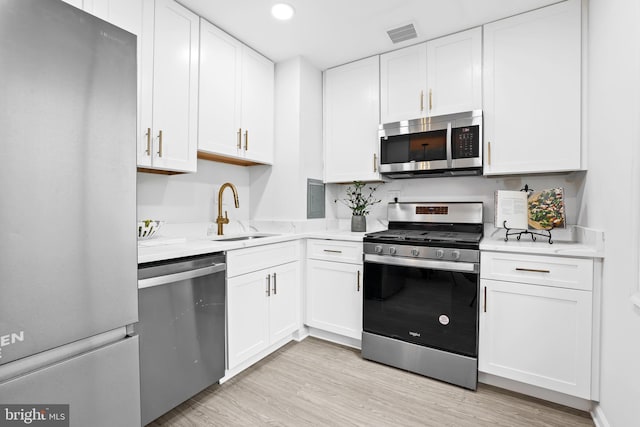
[579,0,640,427]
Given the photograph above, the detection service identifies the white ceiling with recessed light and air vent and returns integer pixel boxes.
[179,0,558,70]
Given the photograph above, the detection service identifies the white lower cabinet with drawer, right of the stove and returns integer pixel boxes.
[478,252,593,399]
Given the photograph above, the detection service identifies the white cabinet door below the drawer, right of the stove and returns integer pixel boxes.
[478,279,592,399]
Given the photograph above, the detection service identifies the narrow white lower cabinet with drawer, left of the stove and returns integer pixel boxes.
[305,240,363,340]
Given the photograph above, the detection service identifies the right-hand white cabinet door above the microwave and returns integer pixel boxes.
[425,27,482,116]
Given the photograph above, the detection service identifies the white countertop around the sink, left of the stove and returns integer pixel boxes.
[138,230,365,264]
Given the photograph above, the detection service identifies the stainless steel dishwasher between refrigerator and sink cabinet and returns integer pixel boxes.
[136,253,226,425]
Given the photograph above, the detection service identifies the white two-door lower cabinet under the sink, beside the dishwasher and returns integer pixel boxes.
[227,241,300,369]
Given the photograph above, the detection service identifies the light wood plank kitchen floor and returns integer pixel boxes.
[150,338,593,427]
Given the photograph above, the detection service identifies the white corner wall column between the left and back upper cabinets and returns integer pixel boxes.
[250,57,322,220]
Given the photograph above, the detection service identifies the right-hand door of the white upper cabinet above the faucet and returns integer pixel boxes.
[241,46,275,164]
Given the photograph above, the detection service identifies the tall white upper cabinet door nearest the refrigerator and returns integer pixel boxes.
[148,0,199,172]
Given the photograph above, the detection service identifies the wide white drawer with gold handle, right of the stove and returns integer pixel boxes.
[480,252,593,291]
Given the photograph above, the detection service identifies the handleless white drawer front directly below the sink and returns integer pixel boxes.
[227,240,300,277]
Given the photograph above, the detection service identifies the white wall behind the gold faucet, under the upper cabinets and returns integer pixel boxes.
[137,160,250,223]
